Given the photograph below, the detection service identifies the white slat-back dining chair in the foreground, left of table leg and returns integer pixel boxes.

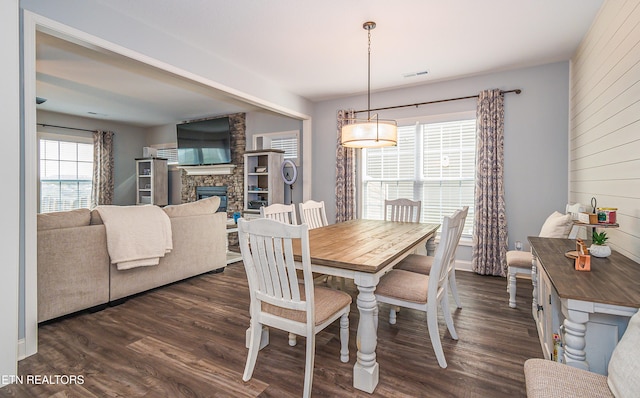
[238,219,351,397]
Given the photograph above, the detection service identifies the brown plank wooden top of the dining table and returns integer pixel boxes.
[293,220,440,273]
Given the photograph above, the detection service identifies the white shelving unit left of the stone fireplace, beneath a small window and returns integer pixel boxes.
[136,158,169,206]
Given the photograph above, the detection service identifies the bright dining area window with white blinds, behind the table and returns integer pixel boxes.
[361,118,476,236]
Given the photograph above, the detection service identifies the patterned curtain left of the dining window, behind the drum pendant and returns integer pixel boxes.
[336,109,357,222]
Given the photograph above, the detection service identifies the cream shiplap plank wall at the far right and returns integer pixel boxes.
[569,0,640,262]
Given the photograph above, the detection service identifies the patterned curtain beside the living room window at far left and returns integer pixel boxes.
[91,131,114,208]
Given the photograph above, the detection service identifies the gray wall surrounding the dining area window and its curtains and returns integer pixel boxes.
[311,62,569,259]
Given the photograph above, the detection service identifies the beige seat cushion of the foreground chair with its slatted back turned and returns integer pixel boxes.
[262,284,351,325]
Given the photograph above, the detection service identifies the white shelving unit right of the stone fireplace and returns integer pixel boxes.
[244,149,284,215]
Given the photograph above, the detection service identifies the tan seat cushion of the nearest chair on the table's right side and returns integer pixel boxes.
[375,269,429,304]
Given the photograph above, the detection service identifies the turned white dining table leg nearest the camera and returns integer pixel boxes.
[353,272,380,394]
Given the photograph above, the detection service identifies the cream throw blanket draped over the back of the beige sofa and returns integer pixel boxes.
[96,205,173,270]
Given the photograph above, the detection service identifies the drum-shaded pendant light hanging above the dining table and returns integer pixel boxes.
[341,21,398,148]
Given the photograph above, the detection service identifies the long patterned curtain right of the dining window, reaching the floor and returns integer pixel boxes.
[472,90,507,276]
